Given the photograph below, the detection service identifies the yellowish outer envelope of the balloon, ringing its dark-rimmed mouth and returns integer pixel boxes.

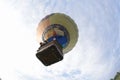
[37,13,78,53]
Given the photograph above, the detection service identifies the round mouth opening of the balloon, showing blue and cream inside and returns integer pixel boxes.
[42,24,70,48]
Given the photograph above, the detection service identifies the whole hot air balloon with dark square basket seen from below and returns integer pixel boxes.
[36,13,78,66]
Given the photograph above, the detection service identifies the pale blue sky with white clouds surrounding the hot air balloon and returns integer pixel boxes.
[0,0,120,80]
